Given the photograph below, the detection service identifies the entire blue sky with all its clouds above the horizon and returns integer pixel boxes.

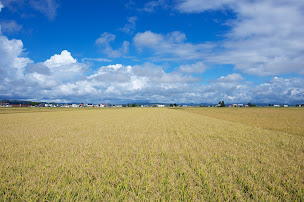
[0,0,304,104]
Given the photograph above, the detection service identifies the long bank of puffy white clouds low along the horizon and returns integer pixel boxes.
[0,30,304,103]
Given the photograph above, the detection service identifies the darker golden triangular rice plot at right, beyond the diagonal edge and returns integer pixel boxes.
[176,107,304,136]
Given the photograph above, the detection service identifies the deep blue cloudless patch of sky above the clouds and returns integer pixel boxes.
[0,0,235,66]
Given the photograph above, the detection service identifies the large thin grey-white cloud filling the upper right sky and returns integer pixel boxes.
[176,0,304,76]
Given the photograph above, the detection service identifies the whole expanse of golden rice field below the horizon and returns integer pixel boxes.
[0,108,304,201]
